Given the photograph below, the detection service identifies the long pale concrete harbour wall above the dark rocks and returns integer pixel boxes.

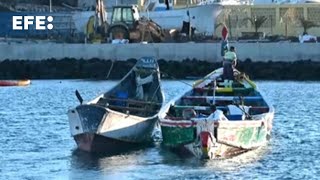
[0,42,320,62]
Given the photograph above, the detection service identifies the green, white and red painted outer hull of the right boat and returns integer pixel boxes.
[160,113,273,159]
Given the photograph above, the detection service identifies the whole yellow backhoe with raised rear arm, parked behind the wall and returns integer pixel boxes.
[86,0,165,43]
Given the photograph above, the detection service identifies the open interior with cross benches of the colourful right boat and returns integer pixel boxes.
[167,74,269,121]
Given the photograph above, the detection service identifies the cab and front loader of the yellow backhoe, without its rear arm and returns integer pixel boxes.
[108,5,165,42]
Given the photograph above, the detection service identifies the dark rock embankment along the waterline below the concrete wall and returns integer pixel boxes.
[0,58,320,81]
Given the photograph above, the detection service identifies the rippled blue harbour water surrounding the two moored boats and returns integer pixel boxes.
[0,80,320,180]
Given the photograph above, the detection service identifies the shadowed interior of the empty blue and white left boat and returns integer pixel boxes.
[97,66,163,117]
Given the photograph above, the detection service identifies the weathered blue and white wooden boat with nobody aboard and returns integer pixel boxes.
[68,58,164,153]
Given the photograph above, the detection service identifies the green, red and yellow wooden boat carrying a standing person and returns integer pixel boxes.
[160,68,274,159]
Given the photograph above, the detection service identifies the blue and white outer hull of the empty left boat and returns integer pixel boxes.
[68,105,158,153]
